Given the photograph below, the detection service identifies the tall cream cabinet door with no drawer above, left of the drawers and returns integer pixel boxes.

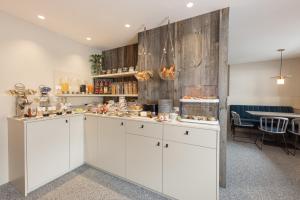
[99,117,125,177]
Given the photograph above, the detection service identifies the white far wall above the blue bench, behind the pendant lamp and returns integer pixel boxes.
[228,58,300,109]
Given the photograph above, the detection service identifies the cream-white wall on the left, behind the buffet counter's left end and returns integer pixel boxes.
[0,12,101,185]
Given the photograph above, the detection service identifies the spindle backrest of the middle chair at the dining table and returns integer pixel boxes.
[260,117,289,133]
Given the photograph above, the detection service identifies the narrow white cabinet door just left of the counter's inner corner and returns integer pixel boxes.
[70,116,84,169]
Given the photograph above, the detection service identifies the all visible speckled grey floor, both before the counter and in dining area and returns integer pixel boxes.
[0,135,300,200]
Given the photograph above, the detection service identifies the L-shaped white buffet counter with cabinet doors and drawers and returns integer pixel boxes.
[8,113,220,200]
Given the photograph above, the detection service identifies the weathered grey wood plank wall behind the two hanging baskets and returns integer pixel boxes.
[138,11,220,105]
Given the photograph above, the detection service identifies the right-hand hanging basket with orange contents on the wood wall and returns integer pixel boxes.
[159,20,176,80]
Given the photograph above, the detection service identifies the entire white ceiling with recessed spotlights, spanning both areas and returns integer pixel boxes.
[0,0,300,64]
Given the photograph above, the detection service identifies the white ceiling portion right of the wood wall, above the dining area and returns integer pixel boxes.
[229,0,300,64]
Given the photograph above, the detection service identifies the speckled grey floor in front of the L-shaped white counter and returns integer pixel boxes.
[0,165,167,200]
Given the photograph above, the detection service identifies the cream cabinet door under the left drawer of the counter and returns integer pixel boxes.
[126,134,162,192]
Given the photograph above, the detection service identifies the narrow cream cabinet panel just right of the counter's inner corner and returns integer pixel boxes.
[84,116,99,167]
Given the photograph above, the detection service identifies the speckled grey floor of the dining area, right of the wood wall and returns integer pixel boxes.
[220,136,300,200]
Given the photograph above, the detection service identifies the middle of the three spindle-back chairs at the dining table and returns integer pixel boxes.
[255,117,289,154]
